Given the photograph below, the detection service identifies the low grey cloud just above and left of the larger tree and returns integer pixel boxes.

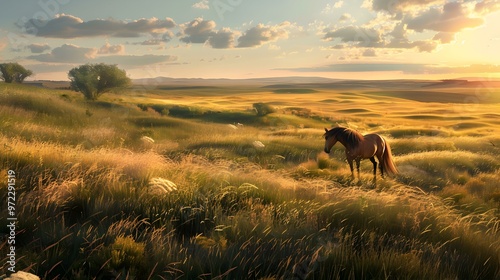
[27,44,97,63]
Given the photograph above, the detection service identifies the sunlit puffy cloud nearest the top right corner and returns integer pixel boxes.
[404,2,484,32]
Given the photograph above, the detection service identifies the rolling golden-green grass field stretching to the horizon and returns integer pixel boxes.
[0,81,500,279]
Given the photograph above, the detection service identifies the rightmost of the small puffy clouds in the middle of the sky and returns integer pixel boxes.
[237,21,293,48]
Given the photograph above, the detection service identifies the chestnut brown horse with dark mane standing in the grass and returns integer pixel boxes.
[323,127,398,180]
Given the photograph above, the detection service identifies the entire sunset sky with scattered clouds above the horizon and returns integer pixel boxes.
[0,0,500,80]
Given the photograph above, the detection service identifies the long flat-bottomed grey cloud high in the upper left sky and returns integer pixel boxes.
[25,14,176,39]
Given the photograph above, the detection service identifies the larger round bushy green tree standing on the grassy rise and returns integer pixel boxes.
[68,63,131,100]
